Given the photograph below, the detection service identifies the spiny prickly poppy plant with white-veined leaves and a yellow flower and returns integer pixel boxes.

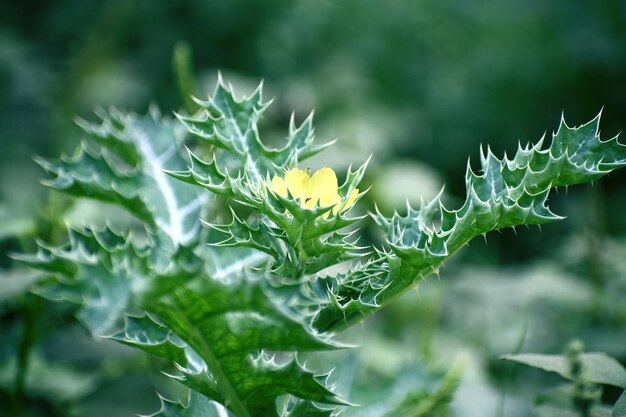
[20,75,626,417]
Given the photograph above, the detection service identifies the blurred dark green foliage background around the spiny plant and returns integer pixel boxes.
[0,0,626,416]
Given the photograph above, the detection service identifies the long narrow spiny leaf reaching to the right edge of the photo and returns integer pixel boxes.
[315,115,626,331]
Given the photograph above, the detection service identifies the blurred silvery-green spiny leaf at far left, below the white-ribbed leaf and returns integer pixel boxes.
[16,227,151,336]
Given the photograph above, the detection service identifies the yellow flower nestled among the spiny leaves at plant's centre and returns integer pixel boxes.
[271,168,359,218]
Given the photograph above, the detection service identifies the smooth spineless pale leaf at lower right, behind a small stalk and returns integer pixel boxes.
[502,353,626,388]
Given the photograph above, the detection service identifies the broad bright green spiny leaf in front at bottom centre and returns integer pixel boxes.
[153,275,342,417]
